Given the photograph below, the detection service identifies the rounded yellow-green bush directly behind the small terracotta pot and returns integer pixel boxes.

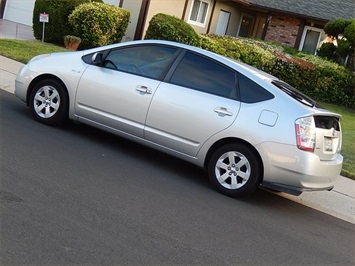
[69,2,130,49]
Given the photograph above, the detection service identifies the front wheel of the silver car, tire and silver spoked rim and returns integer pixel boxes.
[29,79,69,126]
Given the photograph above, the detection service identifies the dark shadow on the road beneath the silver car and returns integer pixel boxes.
[6,94,308,211]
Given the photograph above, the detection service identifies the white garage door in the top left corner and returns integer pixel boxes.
[4,0,35,26]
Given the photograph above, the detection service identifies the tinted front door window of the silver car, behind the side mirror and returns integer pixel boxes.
[103,45,179,79]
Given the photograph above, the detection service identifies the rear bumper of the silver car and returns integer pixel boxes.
[257,143,343,194]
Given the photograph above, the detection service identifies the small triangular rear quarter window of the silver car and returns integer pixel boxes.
[238,74,274,103]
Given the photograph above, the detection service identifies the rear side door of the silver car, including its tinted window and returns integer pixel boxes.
[144,52,240,156]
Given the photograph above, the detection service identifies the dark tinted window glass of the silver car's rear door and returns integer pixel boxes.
[170,52,238,99]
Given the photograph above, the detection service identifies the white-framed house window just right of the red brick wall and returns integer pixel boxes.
[299,26,327,55]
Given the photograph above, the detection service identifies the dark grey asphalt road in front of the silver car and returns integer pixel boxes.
[0,90,355,265]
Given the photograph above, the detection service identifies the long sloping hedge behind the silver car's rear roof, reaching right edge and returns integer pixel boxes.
[202,35,355,108]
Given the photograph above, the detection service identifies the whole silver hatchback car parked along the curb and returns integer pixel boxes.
[15,40,343,197]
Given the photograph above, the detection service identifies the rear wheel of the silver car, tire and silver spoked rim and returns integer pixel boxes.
[207,144,262,198]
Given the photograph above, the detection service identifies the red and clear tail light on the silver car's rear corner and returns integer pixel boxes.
[295,116,316,152]
